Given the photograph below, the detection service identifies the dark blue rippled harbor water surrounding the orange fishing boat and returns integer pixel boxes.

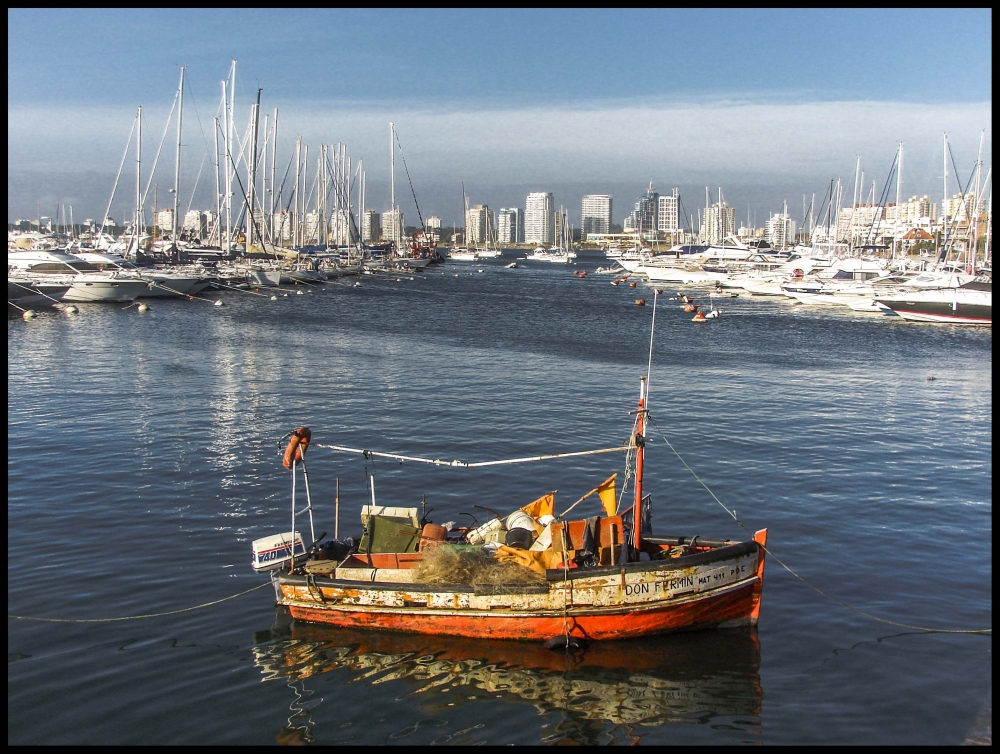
[7,252,993,744]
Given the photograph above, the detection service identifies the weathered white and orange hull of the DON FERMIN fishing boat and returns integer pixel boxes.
[275,532,766,641]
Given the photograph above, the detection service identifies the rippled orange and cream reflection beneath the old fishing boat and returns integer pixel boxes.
[253,608,763,743]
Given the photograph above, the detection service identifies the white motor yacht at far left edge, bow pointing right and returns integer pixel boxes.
[7,249,149,303]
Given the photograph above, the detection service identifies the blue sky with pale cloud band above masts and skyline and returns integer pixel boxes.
[7,9,992,227]
